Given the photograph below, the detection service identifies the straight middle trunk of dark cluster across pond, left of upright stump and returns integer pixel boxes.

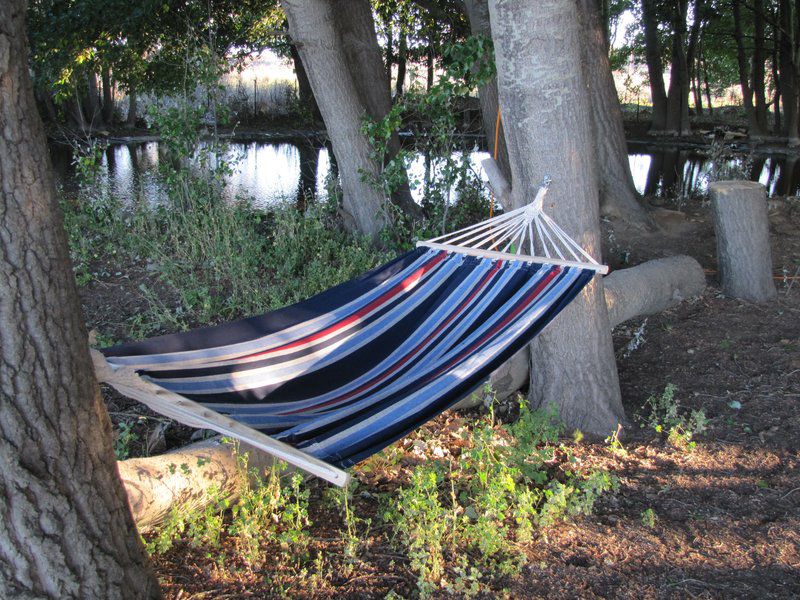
[664,0,690,135]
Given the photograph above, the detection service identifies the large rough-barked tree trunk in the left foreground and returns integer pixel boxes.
[0,0,160,598]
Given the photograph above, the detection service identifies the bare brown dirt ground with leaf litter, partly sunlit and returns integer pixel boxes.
[85,190,800,599]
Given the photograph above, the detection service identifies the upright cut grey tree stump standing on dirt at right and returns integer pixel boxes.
[709,181,777,302]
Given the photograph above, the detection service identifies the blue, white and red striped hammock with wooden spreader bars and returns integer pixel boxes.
[94,188,607,485]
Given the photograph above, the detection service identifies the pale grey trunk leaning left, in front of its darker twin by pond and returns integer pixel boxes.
[282,0,387,238]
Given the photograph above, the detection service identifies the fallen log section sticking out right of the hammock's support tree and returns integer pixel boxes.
[603,256,706,327]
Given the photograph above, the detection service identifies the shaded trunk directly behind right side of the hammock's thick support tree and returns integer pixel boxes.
[578,0,652,227]
